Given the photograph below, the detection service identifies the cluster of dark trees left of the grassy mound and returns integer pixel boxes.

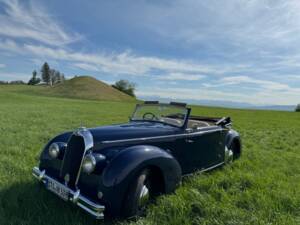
[28,62,65,86]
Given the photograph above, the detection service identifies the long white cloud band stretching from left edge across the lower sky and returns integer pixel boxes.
[0,40,238,76]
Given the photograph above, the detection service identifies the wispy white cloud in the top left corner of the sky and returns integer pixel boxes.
[0,0,81,45]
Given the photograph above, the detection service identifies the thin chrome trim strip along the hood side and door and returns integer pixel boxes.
[101,126,223,144]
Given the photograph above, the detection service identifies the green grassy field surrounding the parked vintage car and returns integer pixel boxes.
[0,86,300,225]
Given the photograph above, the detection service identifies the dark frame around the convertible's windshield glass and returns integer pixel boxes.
[129,103,191,128]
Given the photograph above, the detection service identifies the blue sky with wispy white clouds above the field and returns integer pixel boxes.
[0,0,300,105]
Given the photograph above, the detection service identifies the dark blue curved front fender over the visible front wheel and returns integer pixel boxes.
[101,145,181,216]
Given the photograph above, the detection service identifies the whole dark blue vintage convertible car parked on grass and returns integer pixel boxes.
[33,101,241,219]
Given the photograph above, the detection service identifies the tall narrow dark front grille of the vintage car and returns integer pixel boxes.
[60,134,85,188]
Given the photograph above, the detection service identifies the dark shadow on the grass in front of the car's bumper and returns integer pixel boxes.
[0,182,115,225]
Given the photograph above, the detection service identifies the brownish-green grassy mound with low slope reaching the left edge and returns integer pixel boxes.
[0,76,135,102]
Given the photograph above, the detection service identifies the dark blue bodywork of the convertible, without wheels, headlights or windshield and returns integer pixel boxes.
[33,101,241,218]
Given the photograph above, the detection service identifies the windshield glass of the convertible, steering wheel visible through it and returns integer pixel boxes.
[131,104,187,127]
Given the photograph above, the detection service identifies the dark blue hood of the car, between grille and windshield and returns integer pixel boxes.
[89,122,181,143]
